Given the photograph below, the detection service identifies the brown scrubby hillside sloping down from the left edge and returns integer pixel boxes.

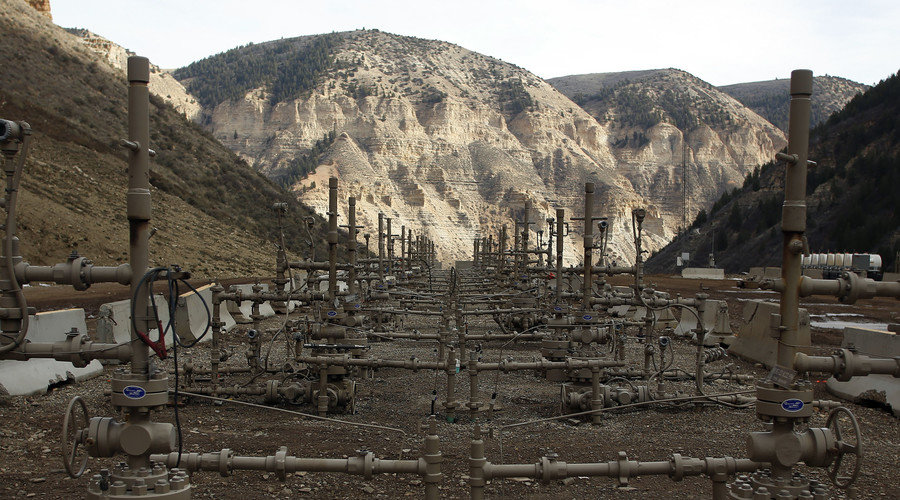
[0,0,330,277]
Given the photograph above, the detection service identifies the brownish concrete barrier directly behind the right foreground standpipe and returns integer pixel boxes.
[728,300,810,368]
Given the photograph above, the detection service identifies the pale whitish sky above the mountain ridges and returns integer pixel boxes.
[51,0,900,85]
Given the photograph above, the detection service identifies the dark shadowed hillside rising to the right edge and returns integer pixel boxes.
[647,69,900,272]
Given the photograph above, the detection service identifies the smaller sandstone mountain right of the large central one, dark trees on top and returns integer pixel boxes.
[549,69,786,236]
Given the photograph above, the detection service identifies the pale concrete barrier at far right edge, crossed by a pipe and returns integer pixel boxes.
[826,327,900,417]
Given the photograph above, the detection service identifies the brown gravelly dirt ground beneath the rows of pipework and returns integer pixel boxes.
[0,276,900,499]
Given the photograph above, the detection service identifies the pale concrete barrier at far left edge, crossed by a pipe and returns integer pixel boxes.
[0,309,103,396]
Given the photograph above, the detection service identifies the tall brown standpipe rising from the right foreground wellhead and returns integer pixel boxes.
[777,69,813,367]
